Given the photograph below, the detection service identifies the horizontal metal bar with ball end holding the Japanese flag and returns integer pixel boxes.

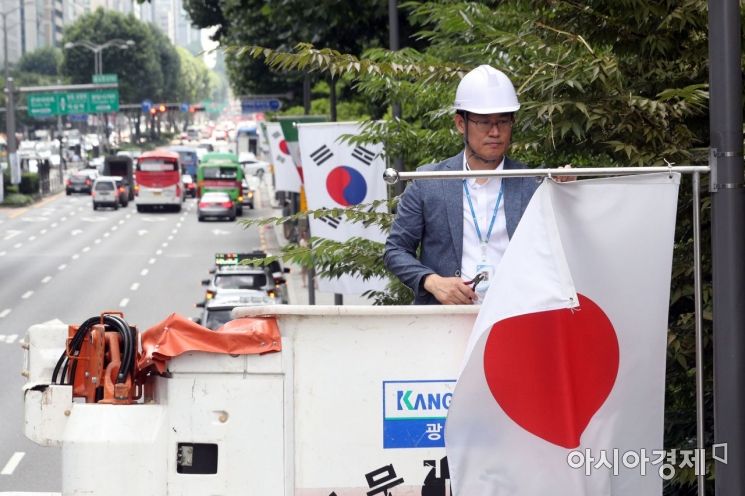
[383,165,711,184]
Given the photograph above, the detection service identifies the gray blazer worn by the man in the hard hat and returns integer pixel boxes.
[384,152,540,304]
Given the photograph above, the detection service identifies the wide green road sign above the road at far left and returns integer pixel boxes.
[27,90,119,117]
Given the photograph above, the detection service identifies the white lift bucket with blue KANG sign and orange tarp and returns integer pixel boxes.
[23,305,478,496]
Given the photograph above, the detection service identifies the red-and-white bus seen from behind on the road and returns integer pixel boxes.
[135,149,184,212]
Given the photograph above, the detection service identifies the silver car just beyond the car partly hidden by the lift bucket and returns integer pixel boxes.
[202,254,289,305]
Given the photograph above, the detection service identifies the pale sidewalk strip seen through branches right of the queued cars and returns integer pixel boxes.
[257,181,372,305]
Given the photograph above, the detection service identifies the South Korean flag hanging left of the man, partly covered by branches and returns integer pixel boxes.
[297,122,387,294]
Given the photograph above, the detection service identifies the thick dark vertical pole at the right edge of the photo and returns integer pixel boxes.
[709,0,745,496]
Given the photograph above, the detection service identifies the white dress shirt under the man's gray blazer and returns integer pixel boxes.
[460,154,510,299]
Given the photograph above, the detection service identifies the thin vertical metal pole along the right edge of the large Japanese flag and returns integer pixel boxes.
[693,172,706,496]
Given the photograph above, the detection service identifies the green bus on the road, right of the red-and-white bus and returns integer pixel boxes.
[197,152,243,215]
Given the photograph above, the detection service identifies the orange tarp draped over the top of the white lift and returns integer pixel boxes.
[137,313,282,374]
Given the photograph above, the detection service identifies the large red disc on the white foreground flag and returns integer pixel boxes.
[484,295,619,449]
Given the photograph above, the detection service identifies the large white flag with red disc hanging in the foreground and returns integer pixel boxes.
[445,174,680,496]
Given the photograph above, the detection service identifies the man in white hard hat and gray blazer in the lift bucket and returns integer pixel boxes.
[384,65,539,304]
